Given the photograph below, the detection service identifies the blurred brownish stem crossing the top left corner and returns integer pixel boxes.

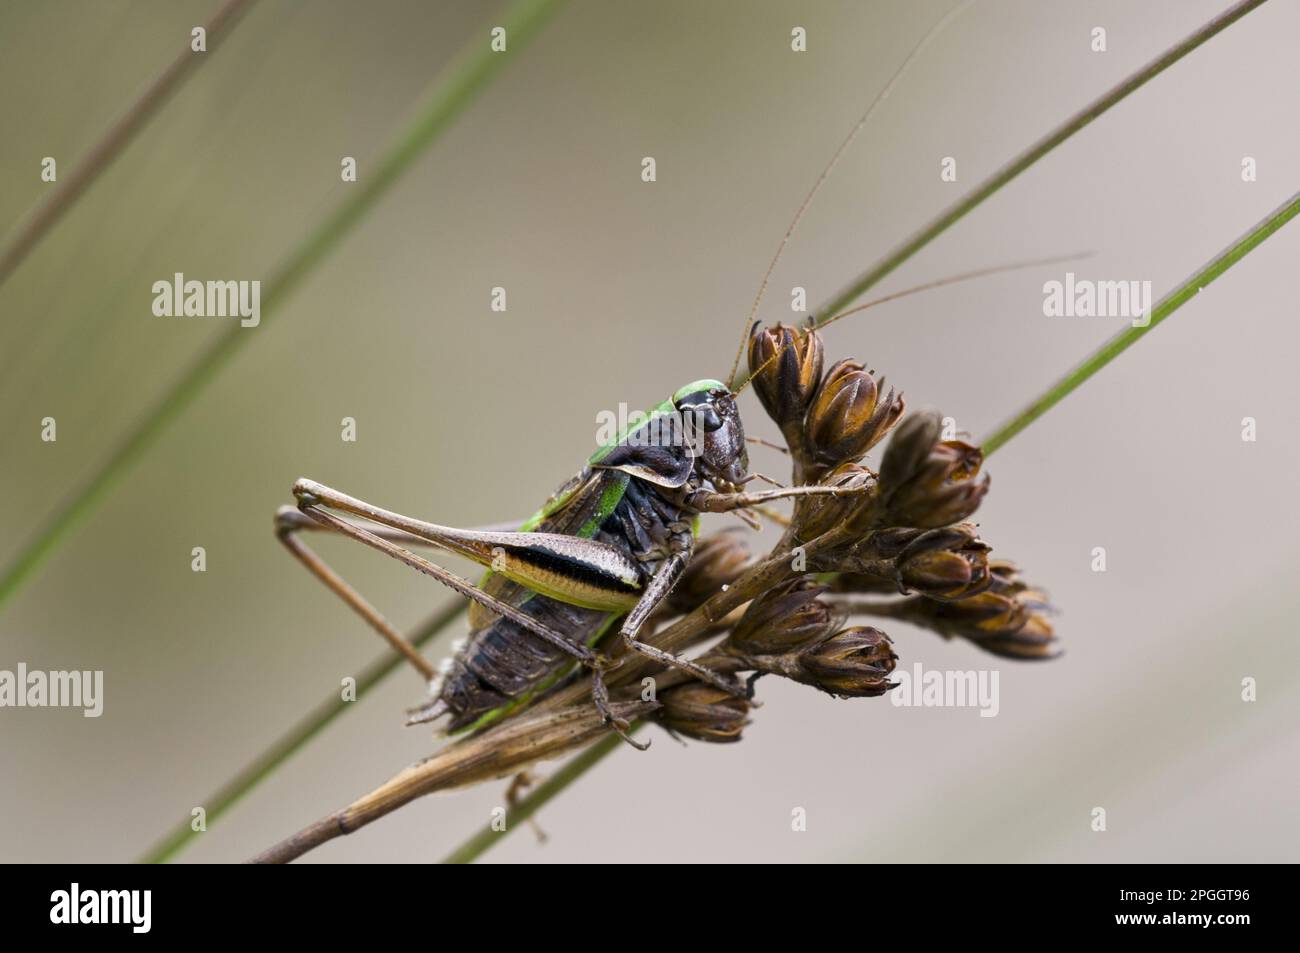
[0,0,254,285]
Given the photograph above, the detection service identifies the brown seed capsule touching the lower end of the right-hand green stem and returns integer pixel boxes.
[880,413,988,528]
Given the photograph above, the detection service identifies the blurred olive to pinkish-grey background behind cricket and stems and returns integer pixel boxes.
[0,0,1300,862]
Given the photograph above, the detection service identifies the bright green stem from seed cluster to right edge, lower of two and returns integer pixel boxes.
[983,192,1300,456]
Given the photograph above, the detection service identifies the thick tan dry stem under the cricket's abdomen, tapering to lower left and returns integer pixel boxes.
[244,701,657,863]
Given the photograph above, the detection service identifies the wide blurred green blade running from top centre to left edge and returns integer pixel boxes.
[0,0,560,606]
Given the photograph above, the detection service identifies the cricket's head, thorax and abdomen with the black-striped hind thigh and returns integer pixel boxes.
[432,380,749,731]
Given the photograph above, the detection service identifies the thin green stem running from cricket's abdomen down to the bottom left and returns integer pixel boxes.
[138,599,465,863]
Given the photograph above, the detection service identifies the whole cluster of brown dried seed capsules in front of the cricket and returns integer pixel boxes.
[655,325,1058,741]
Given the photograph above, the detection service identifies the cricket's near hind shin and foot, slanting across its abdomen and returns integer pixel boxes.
[294,484,645,750]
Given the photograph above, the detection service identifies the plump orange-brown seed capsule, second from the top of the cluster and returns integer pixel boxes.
[807,360,904,467]
